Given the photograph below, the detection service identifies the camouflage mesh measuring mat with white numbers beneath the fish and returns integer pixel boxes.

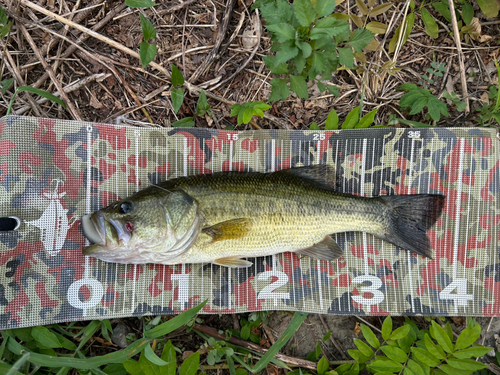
[0,116,500,329]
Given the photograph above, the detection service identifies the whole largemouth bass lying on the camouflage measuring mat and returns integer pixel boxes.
[82,165,444,267]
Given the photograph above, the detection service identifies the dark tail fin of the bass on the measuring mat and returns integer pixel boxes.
[380,194,445,258]
